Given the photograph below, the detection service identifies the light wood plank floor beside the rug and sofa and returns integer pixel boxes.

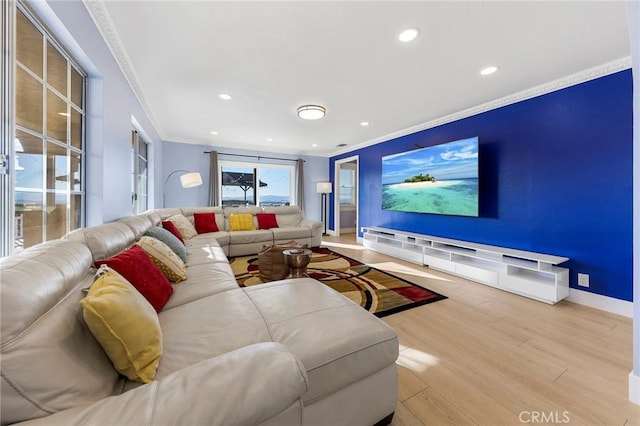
[323,235,640,426]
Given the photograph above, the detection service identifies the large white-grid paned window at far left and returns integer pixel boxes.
[7,3,86,254]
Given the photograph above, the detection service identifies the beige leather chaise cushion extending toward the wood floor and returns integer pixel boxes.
[242,278,398,404]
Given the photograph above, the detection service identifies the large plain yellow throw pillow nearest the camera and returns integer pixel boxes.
[80,266,162,383]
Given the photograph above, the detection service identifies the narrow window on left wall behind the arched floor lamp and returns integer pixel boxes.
[131,130,149,215]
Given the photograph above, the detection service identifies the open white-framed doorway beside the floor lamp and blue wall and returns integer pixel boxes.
[333,155,359,236]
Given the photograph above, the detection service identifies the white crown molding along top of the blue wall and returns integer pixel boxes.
[328,56,631,157]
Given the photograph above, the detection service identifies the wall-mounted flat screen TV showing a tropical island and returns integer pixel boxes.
[382,137,478,216]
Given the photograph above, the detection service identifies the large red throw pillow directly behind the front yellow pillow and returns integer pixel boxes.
[95,246,173,312]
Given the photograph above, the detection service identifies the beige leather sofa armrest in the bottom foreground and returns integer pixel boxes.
[18,343,307,425]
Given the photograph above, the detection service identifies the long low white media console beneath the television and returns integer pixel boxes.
[362,227,569,304]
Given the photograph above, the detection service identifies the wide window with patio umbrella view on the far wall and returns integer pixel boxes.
[220,161,295,207]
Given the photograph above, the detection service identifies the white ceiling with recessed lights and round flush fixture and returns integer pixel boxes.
[85,0,631,156]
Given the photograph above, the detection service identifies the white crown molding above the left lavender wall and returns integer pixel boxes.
[82,0,165,139]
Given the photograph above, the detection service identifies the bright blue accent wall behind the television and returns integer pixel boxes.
[329,70,633,301]
